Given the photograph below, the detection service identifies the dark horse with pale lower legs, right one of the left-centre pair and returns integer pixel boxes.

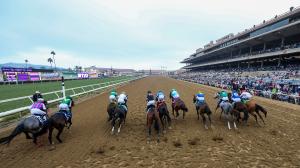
[111,105,127,134]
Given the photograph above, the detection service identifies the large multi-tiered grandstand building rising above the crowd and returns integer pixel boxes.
[181,7,300,71]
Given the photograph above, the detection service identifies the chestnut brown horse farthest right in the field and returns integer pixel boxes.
[246,99,268,125]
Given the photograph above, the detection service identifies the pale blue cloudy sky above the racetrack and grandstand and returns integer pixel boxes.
[0,0,300,70]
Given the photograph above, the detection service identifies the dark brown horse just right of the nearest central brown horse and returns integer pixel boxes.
[157,102,171,132]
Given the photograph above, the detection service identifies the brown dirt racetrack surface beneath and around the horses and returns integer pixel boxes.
[0,77,300,168]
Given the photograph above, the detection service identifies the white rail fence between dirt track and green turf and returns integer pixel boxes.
[0,77,143,118]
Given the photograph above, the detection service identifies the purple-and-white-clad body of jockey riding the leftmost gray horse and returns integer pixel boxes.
[29,98,48,124]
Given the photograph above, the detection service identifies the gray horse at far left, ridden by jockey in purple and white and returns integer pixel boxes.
[0,116,48,144]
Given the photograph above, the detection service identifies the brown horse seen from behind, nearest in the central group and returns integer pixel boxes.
[147,106,160,143]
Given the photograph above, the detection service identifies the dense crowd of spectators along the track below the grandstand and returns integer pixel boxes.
[174,66,300,104]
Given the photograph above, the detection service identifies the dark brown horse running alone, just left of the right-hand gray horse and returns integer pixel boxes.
[193,96,212,129]
